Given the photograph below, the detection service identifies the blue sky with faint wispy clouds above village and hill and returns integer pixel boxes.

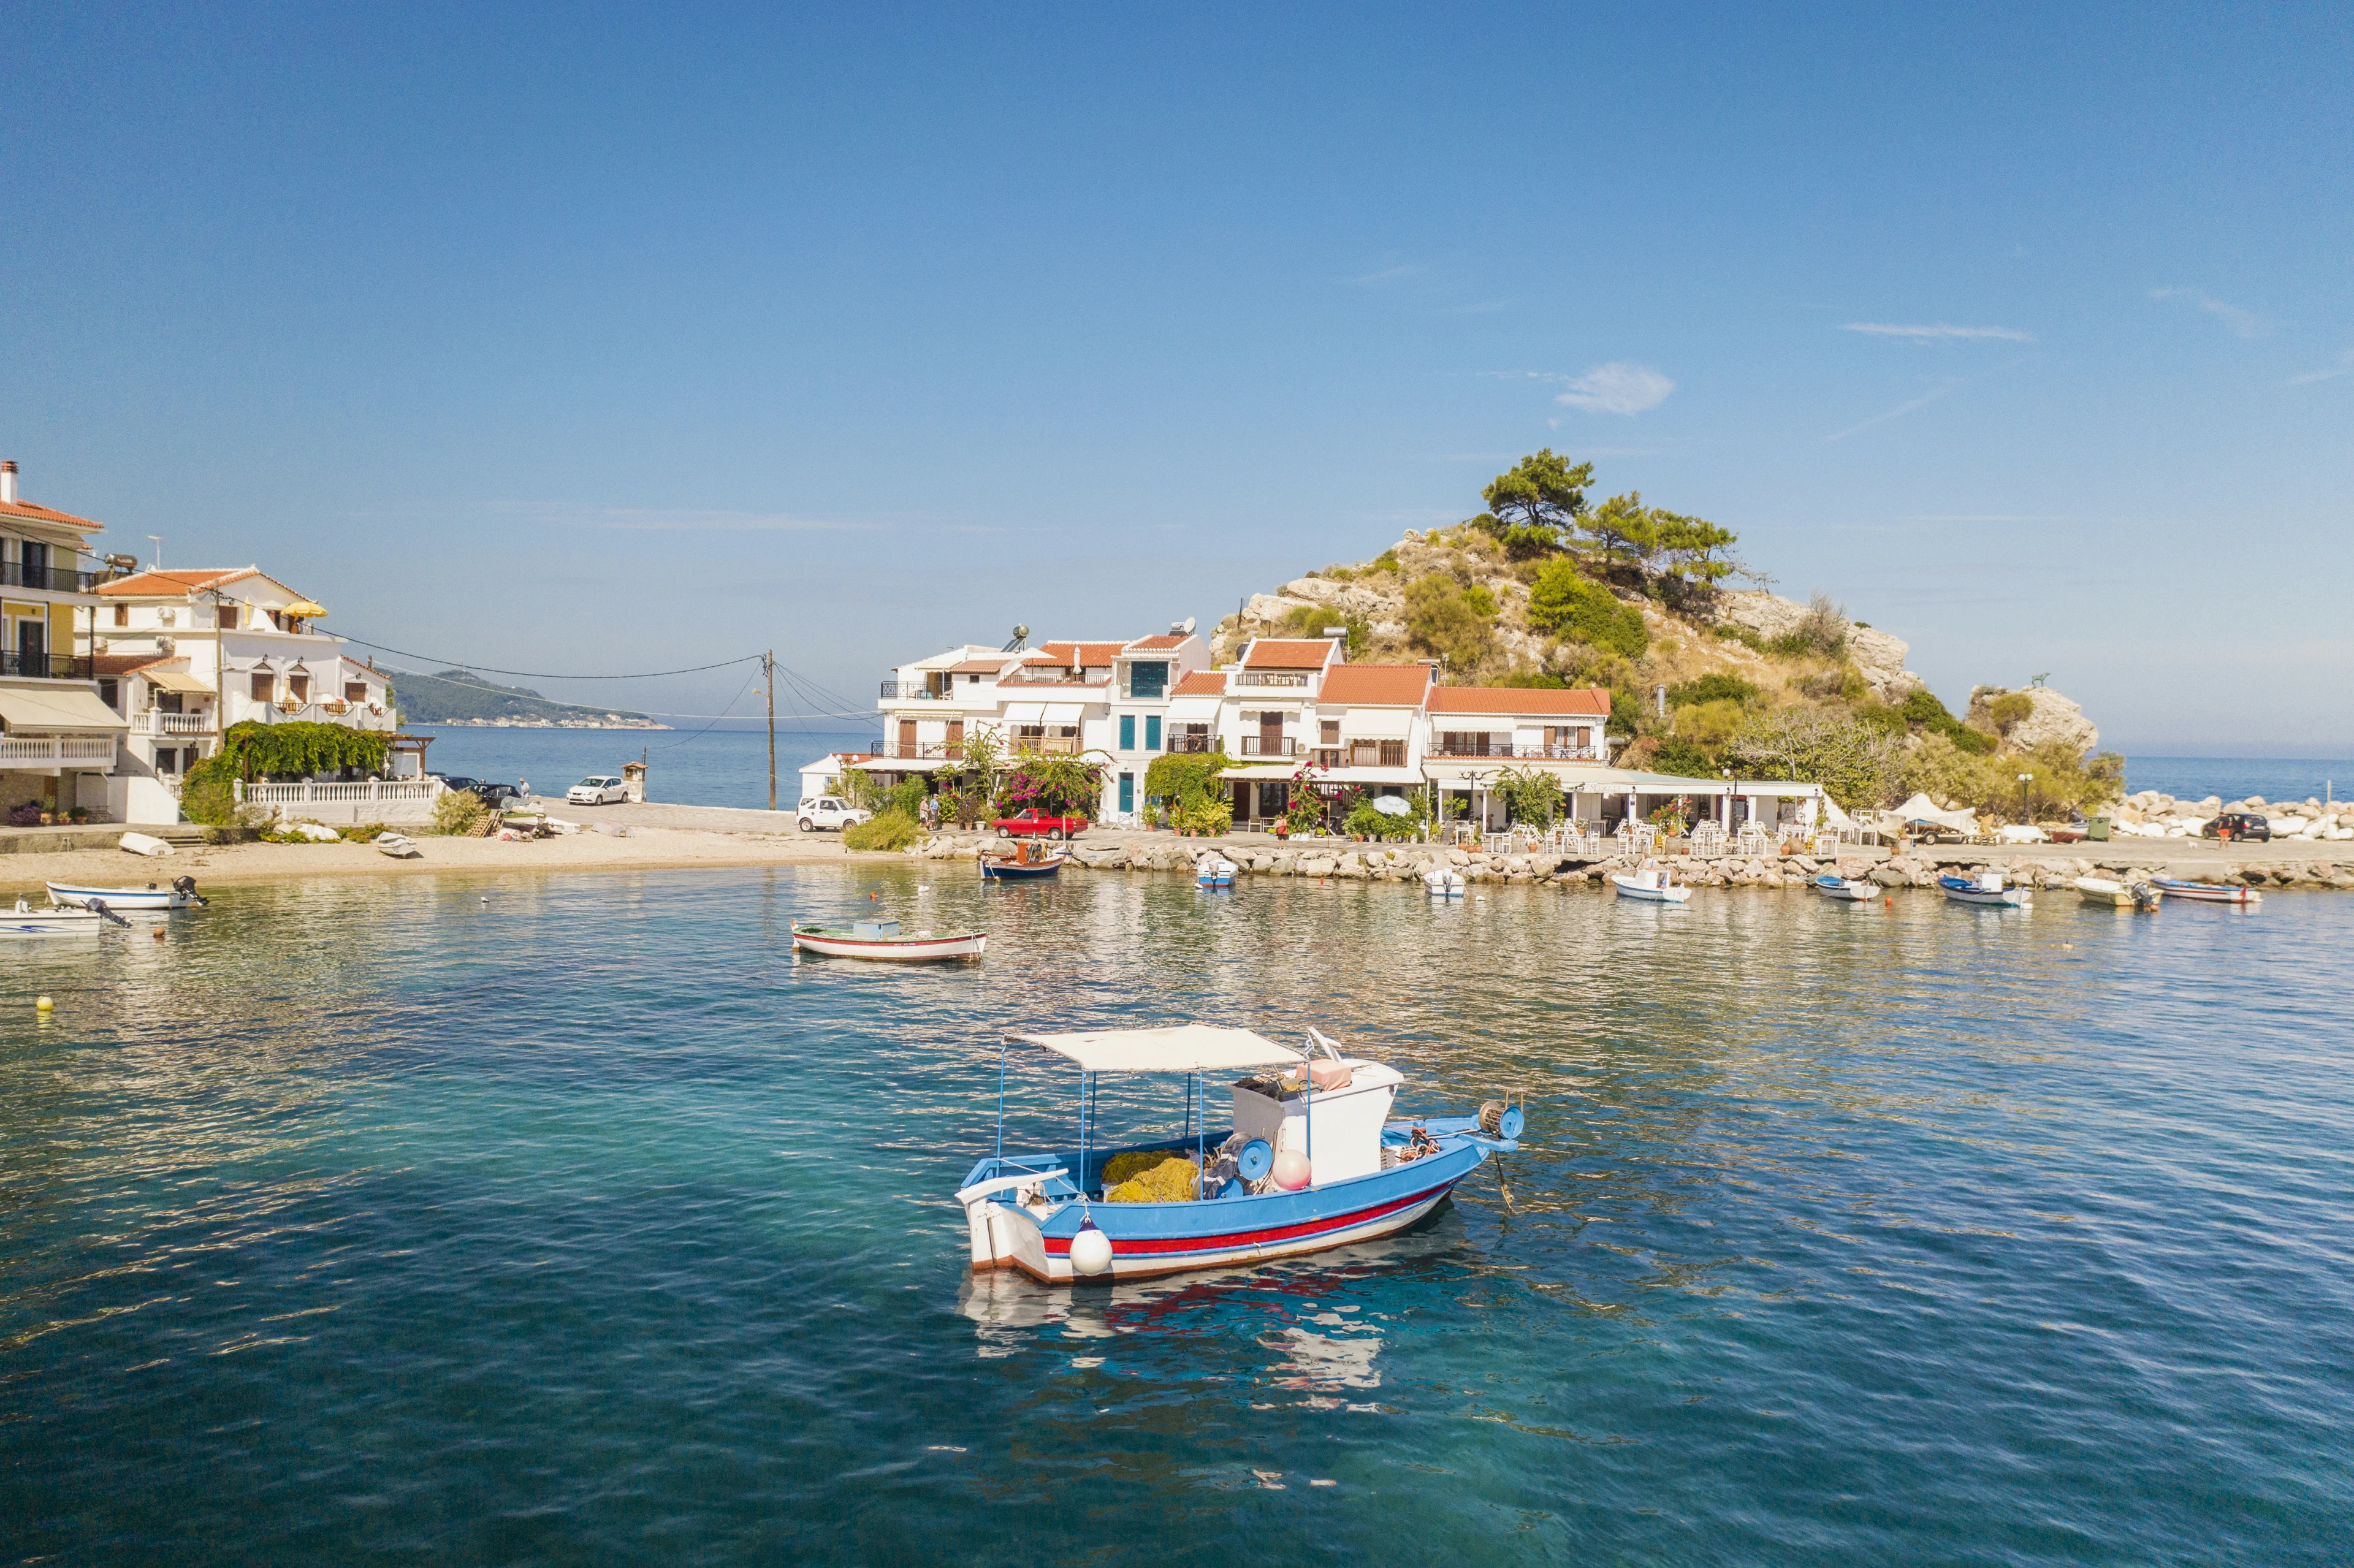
[0,5,2354,756]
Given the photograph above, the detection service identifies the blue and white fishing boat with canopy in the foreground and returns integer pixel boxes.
[956,1024,1523,1285]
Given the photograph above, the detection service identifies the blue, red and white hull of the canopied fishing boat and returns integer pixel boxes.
[967,1140,1514,1285]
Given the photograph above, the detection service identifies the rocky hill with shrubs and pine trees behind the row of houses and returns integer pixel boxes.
[1213,452,2121,817]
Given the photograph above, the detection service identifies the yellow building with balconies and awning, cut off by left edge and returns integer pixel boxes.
[0,462,127,821]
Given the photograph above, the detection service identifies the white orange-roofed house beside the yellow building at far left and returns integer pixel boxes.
[92,568,409,821]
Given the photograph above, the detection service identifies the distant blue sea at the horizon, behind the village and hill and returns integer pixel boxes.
[414,725,2354,807]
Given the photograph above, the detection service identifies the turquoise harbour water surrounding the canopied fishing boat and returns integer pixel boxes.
[0,866,2354,1563]
